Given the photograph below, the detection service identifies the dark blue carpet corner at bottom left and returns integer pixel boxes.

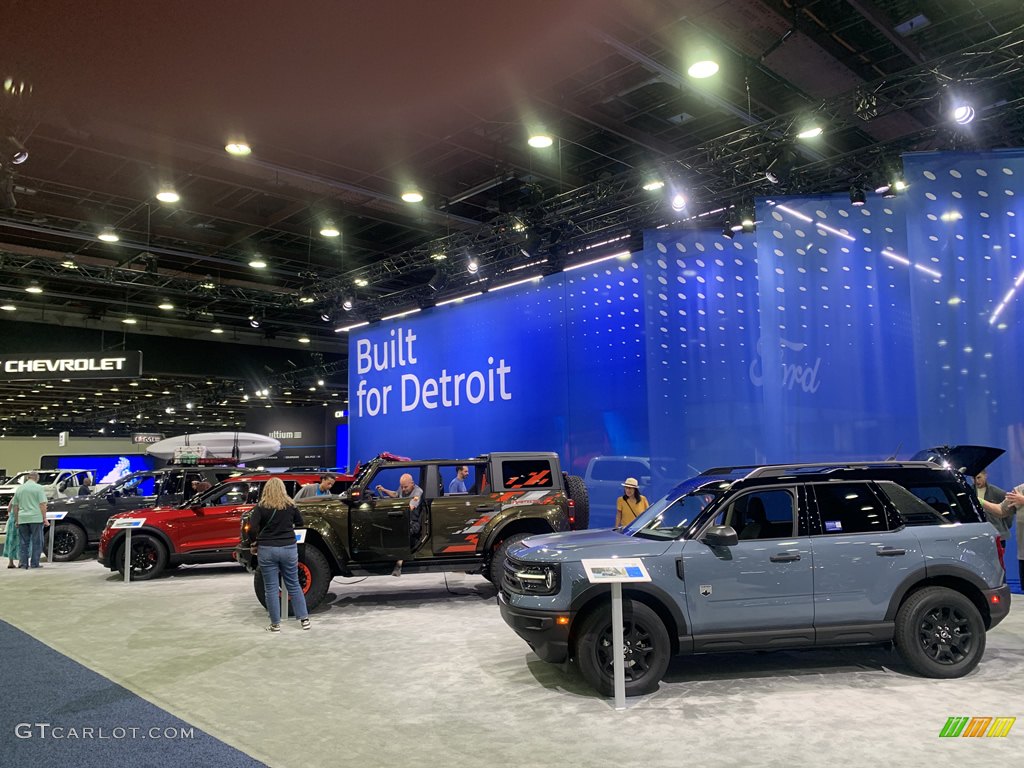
[0,621,263,768]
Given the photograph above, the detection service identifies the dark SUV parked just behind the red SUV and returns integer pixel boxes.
[48,467,252,561]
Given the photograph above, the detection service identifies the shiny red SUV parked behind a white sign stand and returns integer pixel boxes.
[99,472,327,581]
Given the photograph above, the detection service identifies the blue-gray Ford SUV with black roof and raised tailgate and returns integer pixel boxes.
[499,461,1010,695]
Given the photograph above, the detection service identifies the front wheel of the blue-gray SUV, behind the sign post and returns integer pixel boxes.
[575,599,672,696]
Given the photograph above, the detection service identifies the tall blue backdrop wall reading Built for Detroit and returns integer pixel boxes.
[349,151,1024,575]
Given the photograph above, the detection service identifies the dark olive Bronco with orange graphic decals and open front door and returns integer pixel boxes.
[238,453,589,610]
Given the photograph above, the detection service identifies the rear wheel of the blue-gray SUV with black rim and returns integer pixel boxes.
[894,587,985,679]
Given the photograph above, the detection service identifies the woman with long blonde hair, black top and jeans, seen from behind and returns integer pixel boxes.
[249,477,310,632]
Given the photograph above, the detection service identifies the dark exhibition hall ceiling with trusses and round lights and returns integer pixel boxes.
[0,0,1024,433]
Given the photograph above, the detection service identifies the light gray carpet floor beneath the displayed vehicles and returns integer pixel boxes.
[0,560,1024,768]
